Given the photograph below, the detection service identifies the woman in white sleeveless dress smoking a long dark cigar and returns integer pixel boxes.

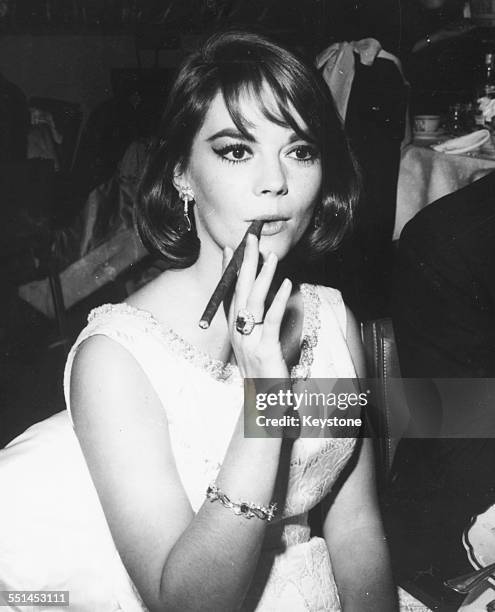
[0,32,426,612]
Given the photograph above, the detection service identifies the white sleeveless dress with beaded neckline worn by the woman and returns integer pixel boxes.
[0,285,426,612]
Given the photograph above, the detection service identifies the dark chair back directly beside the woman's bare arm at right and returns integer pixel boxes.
[361,318,409,482]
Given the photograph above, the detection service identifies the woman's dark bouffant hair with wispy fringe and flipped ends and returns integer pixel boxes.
[136,31,359,268]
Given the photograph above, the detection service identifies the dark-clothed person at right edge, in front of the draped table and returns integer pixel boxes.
[387,172,495,579]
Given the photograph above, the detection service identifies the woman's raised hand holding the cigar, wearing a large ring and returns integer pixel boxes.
[224,234,292,379]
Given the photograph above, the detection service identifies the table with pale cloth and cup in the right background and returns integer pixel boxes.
[393,142,495,240]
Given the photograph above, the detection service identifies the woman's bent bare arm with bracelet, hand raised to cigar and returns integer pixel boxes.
[71,235,290,612]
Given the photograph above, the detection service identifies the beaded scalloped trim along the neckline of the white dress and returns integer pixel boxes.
[88,283,321,383]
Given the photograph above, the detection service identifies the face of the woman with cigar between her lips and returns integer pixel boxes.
[180,87,321,259]
